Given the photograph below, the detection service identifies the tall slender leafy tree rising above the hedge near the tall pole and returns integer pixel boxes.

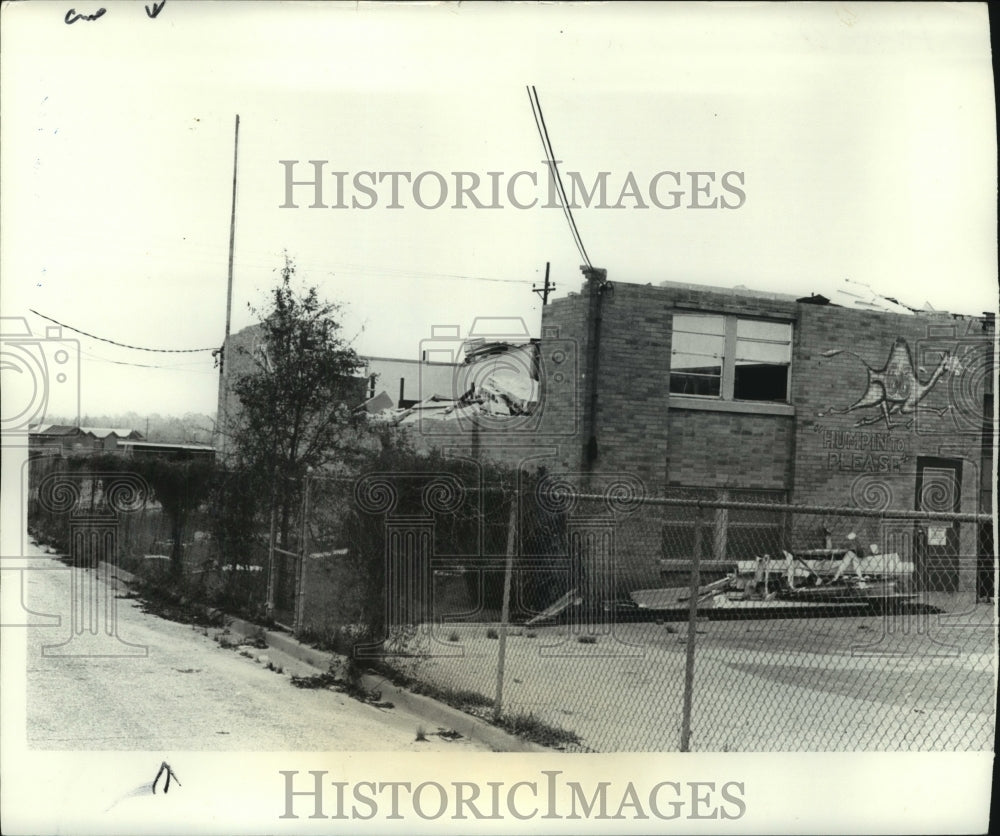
[230,255,364,548]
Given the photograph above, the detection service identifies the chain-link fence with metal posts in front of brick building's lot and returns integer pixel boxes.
[289,474,996,752]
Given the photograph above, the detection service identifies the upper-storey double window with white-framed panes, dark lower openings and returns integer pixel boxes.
[670,314,792,403]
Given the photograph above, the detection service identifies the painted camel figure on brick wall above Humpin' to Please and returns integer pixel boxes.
[816,337,961,428]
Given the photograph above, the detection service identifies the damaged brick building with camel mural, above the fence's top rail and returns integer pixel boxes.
[419,271,995,590]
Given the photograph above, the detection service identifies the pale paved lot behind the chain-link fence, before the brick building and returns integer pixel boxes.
[386,604,997,752]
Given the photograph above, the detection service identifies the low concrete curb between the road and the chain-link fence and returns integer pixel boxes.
[226,616,556,752]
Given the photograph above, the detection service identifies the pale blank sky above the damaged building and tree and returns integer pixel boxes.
[0,0,997,420]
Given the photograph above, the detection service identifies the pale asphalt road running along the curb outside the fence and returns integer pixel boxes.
[24,550,488,752]
